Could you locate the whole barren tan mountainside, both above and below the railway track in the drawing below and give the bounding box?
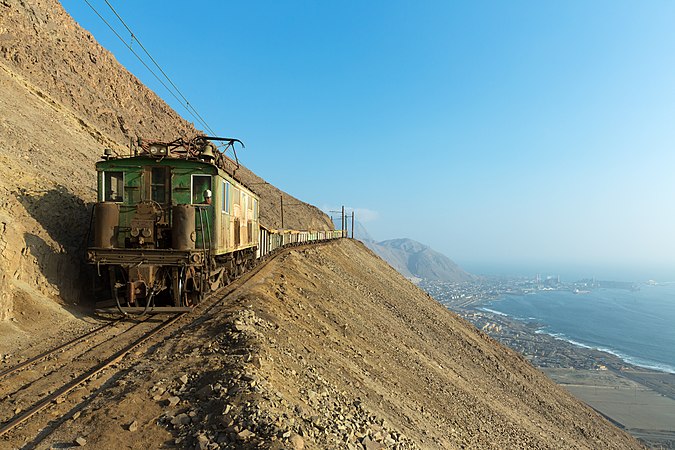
[0,0,640,450]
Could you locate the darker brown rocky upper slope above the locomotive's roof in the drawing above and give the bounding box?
[0,0,195,147]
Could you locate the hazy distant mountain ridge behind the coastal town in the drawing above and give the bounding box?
[364,238,477,282]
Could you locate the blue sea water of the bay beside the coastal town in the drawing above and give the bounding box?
[486,283,675,373]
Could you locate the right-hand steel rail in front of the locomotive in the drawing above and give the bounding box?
[0,314,183,436]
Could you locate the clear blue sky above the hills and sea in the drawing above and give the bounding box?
[63,0,675,279]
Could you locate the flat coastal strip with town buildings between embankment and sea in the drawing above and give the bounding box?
[427,285,675,449]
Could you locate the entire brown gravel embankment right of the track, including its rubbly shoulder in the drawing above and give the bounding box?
[31,240,642,450]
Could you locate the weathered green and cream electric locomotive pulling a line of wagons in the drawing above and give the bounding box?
[86,136,344,314]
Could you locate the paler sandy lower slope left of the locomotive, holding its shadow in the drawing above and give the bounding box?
[0,64,100,322]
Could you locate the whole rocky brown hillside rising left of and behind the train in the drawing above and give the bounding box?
[0,0,332,325]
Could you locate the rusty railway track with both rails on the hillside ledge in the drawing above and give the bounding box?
[0,237,338,446]
